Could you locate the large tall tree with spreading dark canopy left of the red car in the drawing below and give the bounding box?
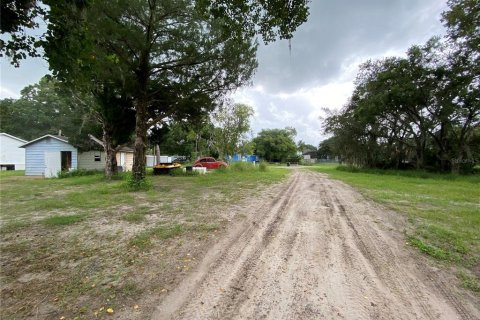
[44,0,308,181]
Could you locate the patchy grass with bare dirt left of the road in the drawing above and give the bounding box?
[0,166,288,319]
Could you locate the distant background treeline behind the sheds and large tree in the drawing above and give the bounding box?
[0,76,300,166]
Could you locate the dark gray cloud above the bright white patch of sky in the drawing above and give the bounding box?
[255,0,445,92]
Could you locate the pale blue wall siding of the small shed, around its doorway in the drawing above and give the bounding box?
[25,137,78,176]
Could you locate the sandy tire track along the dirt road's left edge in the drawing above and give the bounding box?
[153,174,299,319]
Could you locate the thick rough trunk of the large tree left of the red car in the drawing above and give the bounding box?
[132,99,148,183]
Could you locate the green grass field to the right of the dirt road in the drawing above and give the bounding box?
[313,164,480,293]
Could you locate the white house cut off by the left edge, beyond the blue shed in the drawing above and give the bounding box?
[0,132,27,170]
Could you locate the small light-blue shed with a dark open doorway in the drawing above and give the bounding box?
[21,134,77,178]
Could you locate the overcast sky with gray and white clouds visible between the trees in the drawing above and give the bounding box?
[0,0,447,145]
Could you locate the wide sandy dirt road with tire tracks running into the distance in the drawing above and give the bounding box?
[152,170,480,320]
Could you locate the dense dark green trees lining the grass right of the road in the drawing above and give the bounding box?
[323,0,480,172]
